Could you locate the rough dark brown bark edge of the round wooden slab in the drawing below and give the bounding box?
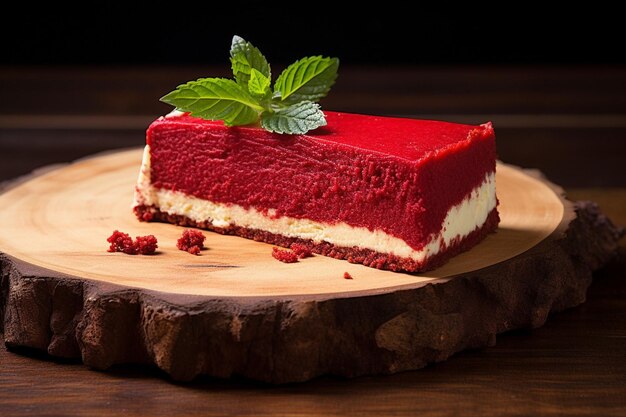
[0,202,624,383]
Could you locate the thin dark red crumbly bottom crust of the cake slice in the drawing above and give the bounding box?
[134,205,500,272]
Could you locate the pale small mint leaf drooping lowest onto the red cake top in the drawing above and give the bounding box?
[261,101,326,135]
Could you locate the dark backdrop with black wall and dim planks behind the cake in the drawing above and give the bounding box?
[0,5,626,187]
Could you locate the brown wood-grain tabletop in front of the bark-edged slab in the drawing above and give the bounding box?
[0,237,626,417]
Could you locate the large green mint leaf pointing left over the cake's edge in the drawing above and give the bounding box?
[161,78,264,126]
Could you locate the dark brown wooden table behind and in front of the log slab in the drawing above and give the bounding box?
[0,68,626,416]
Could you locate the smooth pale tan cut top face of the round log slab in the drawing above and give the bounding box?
[0,149,573,298]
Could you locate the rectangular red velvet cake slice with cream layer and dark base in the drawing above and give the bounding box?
[134,112,499,272]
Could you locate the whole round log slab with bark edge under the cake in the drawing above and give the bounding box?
[0,150,624,383]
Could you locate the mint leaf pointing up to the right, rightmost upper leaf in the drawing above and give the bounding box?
[274,56,339,104]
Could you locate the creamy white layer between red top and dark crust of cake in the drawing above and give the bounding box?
[134,146,497,262]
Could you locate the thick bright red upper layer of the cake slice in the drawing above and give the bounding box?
[147,112,496,249]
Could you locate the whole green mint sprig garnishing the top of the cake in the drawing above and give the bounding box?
[161,36,339,134]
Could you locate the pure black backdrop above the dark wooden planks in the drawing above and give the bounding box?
[0,6,626,65]
